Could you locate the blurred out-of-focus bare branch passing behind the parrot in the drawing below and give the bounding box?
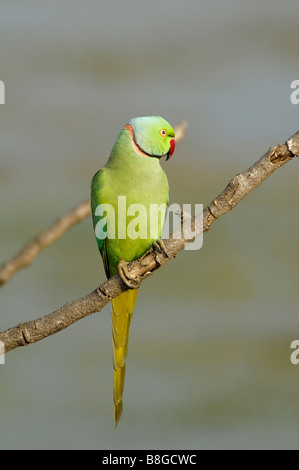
[0,121,188,287]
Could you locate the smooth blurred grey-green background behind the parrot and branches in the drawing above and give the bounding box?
[0,0,299,449]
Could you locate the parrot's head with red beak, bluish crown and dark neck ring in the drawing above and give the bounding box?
[125,116,175,160]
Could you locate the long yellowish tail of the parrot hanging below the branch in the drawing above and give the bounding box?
[111,290,138,427]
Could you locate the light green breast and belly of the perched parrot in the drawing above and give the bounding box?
[92,152,169,276]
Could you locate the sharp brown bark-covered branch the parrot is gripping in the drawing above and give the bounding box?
[0,126,299,352]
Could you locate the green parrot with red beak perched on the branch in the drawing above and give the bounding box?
[91,116,175,427]
